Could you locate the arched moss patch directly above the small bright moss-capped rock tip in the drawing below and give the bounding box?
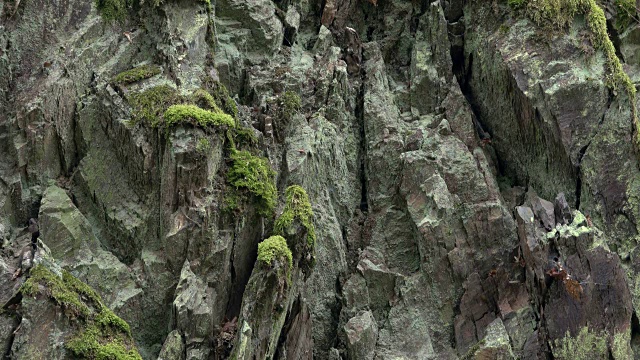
[273,185,316,249]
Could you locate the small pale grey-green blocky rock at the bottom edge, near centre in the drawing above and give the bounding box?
[344,311,378,360]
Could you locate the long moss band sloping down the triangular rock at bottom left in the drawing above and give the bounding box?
[20,264,142,360]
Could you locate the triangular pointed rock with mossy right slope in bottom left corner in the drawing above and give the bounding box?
[10,256,141,359]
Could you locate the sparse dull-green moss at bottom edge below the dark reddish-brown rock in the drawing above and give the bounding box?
[551,326,609,360]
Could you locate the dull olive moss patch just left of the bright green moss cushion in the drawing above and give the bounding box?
[128,85,183,126]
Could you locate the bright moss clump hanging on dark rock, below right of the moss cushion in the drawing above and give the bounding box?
[227,145,278,216]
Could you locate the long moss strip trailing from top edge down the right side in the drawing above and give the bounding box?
[523,0,640,163]
